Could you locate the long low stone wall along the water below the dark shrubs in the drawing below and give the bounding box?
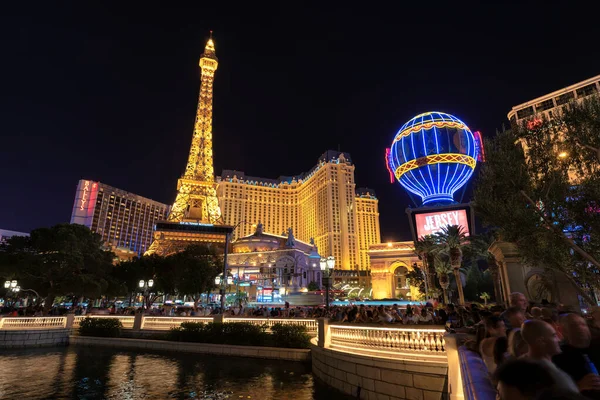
[69,336,310,361]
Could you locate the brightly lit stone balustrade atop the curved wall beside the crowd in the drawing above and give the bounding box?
[319,321,447,362]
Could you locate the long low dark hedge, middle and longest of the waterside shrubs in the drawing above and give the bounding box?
[168,322,268,346]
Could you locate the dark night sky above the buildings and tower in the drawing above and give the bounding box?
[0,1,600,240]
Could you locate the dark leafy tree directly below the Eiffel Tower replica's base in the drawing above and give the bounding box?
[168,245,223,308]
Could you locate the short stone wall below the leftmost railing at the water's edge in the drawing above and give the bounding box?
[0,329,70,349]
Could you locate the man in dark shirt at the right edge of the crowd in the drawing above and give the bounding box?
[553,314,600,399]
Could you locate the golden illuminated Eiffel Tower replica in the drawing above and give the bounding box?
[145,31,232,256]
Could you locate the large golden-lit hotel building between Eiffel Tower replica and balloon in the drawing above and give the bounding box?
[217,151,380,270]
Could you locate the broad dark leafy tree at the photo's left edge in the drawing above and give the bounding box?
[0,224,114,311]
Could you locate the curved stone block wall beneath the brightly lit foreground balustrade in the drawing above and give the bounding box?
[311,346,448,400]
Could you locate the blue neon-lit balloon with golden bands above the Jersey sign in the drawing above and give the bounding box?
[386,111,477,205]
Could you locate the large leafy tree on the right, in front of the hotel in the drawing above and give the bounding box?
[475,97,600,304]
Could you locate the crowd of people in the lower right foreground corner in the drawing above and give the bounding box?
[467,293,600,400]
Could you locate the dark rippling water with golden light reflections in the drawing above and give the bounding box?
[0,346,346,400]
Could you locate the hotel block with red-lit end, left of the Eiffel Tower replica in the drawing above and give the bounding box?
[71,179,169,255]
